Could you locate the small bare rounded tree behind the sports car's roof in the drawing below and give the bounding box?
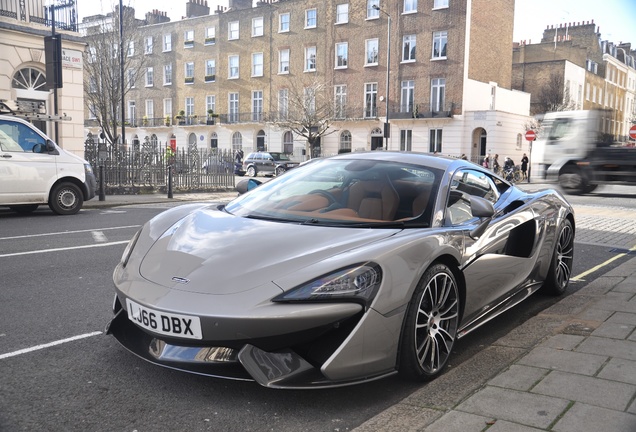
[270,80,337,156]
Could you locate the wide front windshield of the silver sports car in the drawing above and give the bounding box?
[225,157,443,227]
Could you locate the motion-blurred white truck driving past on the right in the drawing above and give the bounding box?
[531,110,636,194]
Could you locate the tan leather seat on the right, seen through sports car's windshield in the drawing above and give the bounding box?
[347,179,400,221]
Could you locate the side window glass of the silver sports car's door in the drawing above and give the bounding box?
[446,170,499,225]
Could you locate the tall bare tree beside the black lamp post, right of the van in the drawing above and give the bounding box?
[84,7,145,145]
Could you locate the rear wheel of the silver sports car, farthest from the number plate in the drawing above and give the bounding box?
[541,219,574,296]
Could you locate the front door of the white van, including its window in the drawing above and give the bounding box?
[0,120,57,204]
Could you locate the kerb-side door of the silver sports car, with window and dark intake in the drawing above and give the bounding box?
[446,169,537,324]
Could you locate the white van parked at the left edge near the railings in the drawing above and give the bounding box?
[0,115,96,215]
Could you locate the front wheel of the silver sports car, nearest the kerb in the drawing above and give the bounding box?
[398,263,460,381]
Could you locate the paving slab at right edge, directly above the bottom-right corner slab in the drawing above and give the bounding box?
[532,371,636,411]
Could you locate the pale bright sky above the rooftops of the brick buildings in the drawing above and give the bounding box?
[77,0,636,49]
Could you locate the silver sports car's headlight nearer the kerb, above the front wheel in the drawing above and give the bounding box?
[272,263,382,307]
